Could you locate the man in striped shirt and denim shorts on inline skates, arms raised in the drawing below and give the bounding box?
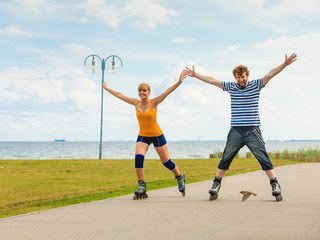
[186,53,297,201]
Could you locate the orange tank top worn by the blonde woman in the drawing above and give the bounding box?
[136,102,162,137]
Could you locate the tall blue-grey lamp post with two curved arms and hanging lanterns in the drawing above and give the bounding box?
[84,54,123,159]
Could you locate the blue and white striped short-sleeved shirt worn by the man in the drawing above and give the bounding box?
[222,78,263,127]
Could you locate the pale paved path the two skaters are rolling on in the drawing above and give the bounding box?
[0,163,320,240]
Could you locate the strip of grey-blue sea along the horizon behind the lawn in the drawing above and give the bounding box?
[0,140,320,160]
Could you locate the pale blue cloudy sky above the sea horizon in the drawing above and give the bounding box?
[0,0,320,141]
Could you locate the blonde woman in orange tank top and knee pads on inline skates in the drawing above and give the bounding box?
[102,70,187,199]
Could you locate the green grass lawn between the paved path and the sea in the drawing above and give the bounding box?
[0,159,301,218]
